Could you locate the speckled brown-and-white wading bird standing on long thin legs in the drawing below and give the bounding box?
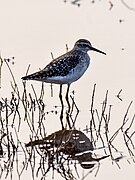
[22,39,106,119]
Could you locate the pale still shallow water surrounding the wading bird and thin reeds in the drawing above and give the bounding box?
[0,0,135,180]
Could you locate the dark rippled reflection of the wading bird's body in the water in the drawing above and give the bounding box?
[26,130,108,169]
